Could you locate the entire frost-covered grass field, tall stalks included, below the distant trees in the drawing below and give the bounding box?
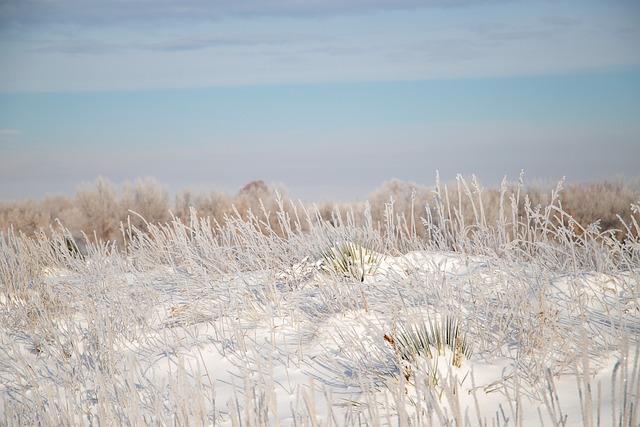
[0,177,640,426]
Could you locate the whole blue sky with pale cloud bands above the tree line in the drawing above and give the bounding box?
[0,0,640,201]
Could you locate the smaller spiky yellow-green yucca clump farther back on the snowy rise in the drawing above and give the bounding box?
[322,241,384,282]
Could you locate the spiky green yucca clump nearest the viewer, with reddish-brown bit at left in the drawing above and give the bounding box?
[384,316,473,380]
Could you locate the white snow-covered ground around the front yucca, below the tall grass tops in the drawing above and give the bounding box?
[0,226,640,426]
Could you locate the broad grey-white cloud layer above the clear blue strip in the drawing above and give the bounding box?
[0,0,640,91]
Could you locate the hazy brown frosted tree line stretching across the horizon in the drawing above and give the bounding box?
[0,177,640,247]
